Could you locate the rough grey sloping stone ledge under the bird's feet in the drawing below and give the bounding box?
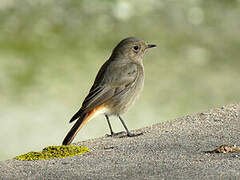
[0,104,240,179]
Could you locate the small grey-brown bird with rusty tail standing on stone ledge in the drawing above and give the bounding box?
[62,37,156,145]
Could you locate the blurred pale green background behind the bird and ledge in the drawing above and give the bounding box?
[0,0,240,160]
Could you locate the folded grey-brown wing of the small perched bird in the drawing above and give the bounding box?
[81,62,138,112]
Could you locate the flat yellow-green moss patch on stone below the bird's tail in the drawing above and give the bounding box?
[14,145,89,161]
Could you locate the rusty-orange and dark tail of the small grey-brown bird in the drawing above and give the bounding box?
[62,106,104,145]
